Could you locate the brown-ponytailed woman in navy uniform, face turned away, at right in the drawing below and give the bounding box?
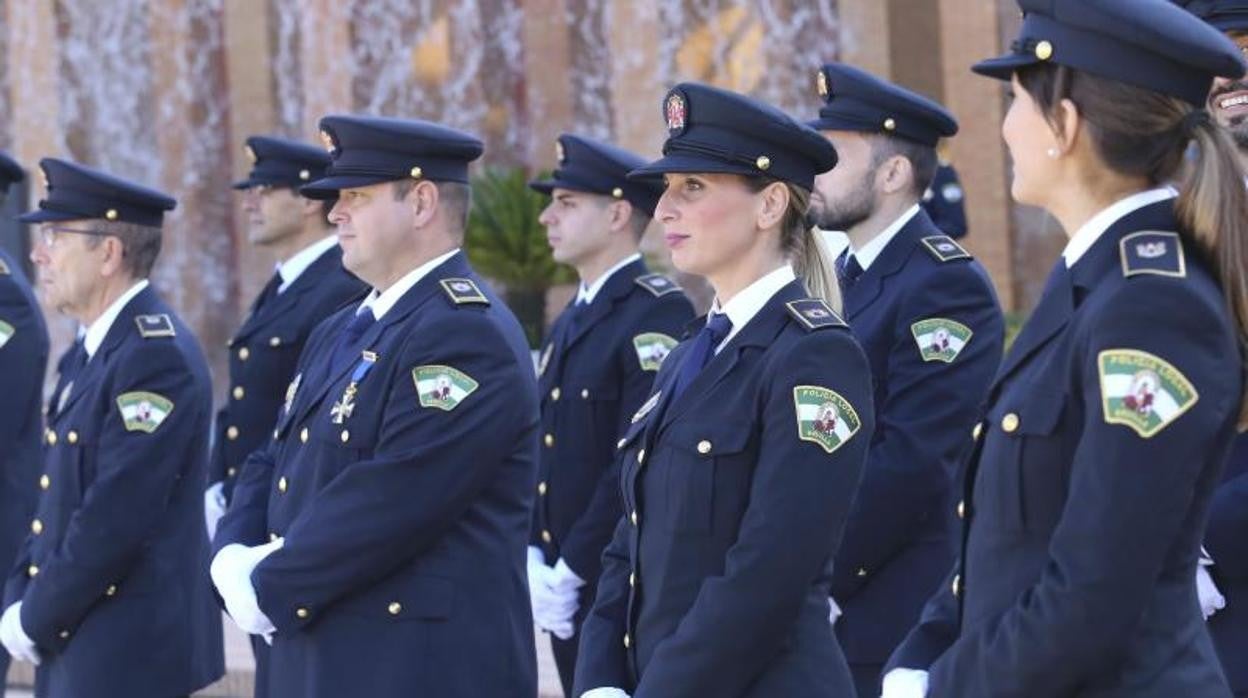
[884,0,1248,698]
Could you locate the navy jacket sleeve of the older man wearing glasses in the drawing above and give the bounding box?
[21,340,211,648]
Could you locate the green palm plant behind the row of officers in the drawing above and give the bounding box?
[464,167,575,347]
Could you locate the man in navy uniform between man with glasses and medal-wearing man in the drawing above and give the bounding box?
[205,136,364,536]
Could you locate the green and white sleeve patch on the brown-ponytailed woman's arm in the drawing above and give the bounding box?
[1097,350,1201,438]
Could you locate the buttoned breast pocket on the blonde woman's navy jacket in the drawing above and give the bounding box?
[655,422,756,533]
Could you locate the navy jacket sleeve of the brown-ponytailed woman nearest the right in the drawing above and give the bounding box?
[929,277,1241,698]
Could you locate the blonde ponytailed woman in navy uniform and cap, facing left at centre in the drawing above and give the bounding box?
[575,84,874,698]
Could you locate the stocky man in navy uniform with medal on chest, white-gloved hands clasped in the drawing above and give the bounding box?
[211,116,538,698]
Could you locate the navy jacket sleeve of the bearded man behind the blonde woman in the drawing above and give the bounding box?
[832,262,1005,603]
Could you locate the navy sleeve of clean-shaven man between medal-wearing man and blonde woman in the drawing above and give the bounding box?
[559,293,693,579]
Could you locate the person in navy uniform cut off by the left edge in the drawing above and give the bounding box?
[0,152,47,677]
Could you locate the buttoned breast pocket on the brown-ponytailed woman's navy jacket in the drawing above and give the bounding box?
[976,387,1070,532]
